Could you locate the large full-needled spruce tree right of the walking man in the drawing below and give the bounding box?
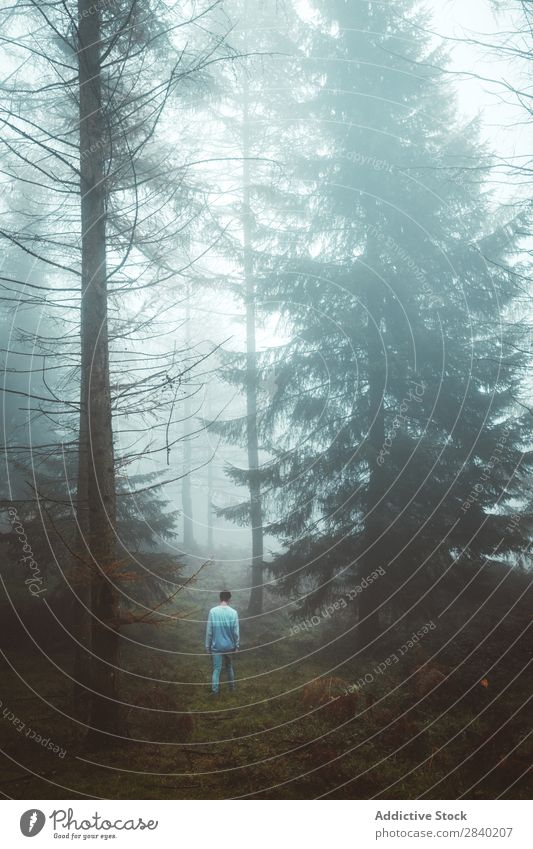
[256,0,527,651]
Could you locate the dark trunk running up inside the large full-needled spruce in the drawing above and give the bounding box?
[357,208,386,652]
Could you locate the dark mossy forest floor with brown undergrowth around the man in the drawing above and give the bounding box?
[0,572,533,799]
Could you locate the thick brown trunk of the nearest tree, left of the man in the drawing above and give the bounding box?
[78,0,122,742]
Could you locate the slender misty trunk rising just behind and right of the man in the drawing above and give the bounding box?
[242,72,264,616]
